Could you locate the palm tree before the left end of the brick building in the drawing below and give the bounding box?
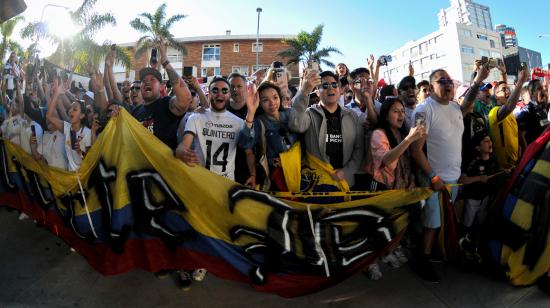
[130,3,187,58]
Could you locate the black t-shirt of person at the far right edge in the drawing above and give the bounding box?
[517,102,548,144]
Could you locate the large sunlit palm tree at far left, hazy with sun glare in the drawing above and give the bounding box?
[21,0,131,73]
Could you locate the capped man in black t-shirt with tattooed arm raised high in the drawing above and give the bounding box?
[132,42,191,150]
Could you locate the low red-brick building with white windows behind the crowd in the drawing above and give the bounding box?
[113,31,298,82]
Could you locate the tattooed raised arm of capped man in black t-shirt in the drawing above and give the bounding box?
[159,40,192,116]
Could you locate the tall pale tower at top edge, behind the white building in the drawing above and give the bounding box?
[437,0,493,31]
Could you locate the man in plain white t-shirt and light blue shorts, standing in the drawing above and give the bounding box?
[411,69,473,283]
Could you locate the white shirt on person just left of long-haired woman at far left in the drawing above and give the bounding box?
[38,130,68,170]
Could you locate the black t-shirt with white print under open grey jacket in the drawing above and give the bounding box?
[323,106,344,169]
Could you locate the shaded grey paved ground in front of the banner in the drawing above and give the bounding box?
[0,208,550,308]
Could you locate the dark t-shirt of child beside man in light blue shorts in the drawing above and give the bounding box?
[464,156,498,200]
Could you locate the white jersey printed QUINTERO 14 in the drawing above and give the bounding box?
[185,109,244,180]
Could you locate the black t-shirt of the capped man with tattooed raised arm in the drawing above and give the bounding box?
[132,96,182,150]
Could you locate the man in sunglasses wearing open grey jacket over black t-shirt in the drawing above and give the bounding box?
[289,71,363,187]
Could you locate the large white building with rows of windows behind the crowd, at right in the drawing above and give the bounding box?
[381,23,502,84]
